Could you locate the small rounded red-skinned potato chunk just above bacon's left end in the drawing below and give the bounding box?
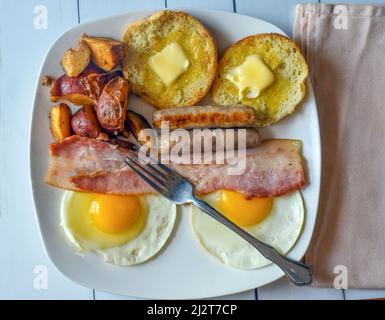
[71,105,101,138]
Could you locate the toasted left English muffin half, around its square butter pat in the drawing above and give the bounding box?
[122,10,218,109]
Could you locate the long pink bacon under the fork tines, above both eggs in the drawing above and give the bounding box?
[46,136,306,198]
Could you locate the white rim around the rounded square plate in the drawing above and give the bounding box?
[28,7,322,299]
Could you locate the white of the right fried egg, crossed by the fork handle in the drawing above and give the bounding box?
[191,191,305,269]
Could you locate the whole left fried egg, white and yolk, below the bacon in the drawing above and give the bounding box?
[61,191,176,266]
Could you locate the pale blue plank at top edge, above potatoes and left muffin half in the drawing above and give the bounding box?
[79,0,165,22]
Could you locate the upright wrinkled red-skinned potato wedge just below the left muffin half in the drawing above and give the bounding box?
[95,77,129,135]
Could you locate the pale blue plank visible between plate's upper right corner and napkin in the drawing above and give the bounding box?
[236,0,318,36]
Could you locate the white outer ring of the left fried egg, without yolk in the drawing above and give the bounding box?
[61,191,176,266]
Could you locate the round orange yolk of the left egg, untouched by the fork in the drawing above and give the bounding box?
[89,195,141,234]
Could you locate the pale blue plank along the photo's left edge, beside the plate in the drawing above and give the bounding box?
[0,0,92,299]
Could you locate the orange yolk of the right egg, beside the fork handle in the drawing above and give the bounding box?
[216,190,273,227]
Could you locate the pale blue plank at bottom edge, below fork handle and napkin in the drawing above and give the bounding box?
[258,278,344,300]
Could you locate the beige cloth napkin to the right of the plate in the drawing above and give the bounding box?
[294,4,385,288]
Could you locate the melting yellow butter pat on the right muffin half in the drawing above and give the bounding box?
[226,54,274,99]
